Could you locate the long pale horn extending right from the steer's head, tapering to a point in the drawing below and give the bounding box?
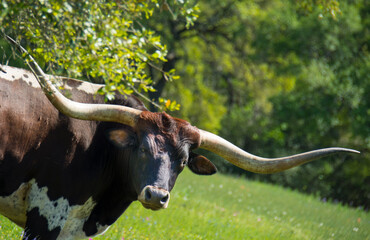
[199,129,360,173]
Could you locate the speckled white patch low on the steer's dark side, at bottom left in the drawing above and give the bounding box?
[0,179,109,240]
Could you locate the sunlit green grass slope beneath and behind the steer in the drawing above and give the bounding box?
[0,170,370,240]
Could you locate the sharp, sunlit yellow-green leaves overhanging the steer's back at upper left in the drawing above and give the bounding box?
[0,0,197,107]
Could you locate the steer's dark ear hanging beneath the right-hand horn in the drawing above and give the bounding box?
[188,153,217,175]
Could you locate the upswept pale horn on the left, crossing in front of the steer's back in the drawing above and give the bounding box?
[6,36,142,127]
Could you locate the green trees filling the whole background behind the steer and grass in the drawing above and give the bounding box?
[0,0,370,208]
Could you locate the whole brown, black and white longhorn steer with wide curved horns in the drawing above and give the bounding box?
[0,37,357,239]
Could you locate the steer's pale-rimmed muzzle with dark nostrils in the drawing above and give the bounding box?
[138,186,170,210]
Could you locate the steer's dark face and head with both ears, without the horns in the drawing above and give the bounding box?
[108,111,217,210]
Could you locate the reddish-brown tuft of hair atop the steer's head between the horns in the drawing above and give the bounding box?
[137,111,200,148]
